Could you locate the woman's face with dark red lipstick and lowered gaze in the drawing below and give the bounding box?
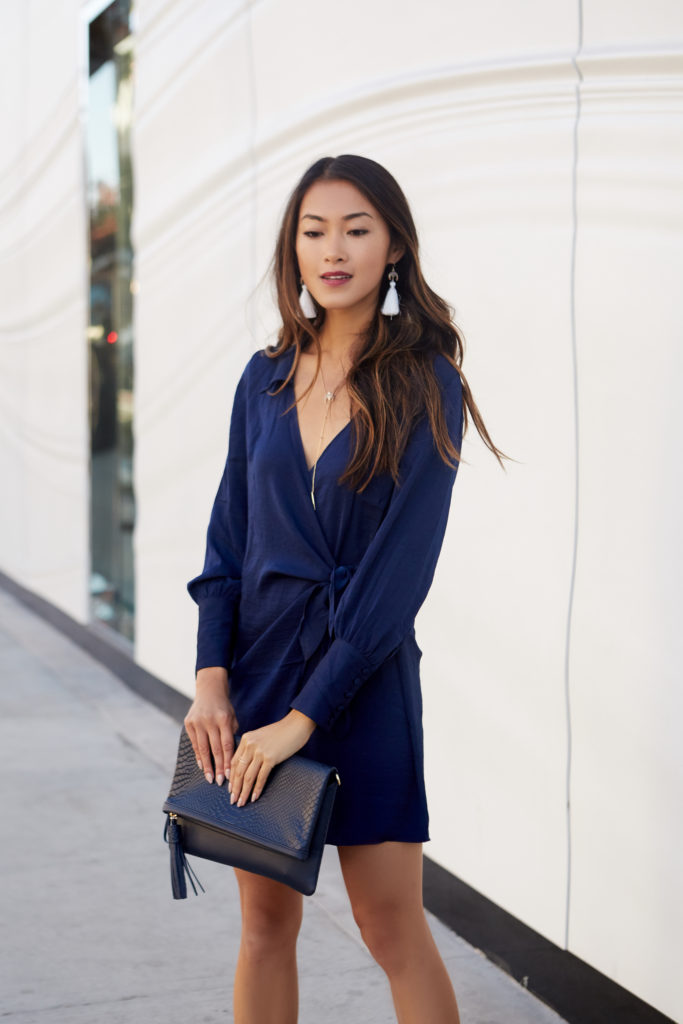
[296,181,404,319]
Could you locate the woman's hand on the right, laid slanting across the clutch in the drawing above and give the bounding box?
[228,709,315,807]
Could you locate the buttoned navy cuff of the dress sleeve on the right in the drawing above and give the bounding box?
[290,638,373,731]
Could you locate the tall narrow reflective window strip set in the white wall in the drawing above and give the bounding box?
[86,0,135,641]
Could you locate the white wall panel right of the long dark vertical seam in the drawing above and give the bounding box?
[569,8,683,1003]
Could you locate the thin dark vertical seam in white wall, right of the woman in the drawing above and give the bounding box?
[564,0,584,949]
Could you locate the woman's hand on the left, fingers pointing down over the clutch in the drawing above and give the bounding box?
[184,668,239,785]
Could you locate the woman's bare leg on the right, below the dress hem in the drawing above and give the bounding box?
[339,843,460,1024]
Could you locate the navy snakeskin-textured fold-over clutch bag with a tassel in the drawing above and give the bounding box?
[164,726,339,899]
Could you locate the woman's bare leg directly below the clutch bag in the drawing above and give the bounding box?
[233,868,303,1024]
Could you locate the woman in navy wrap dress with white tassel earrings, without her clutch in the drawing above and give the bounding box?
[185,156,500,1024]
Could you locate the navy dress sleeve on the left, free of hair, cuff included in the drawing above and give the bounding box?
[187,374,247,672]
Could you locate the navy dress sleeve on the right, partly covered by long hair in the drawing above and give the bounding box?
[291,367,463,730]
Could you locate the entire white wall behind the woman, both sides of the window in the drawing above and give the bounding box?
[0,0,683,1018]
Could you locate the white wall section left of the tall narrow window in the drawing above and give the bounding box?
[0,0,89,621]
